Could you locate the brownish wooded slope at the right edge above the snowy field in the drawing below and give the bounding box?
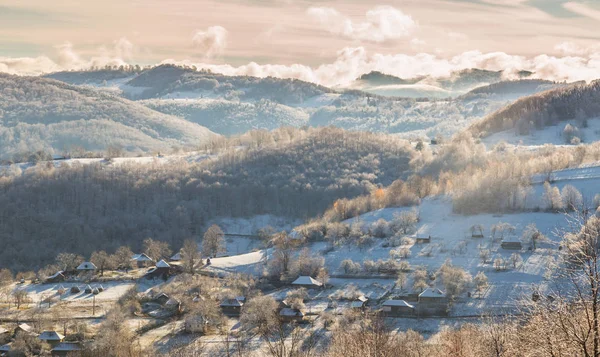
[471,81,600,136]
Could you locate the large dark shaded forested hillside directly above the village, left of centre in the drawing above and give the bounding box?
[0,128,416,269]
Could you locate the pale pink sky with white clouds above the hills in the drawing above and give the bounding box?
[0,0,600,86]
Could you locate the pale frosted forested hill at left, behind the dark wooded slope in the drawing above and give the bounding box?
[0,74,215,159]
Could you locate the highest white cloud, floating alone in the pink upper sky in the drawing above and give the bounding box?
[307,6,417,42]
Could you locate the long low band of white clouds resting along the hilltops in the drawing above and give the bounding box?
[0,39,600,87]
